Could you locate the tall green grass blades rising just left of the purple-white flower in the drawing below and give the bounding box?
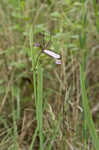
[30,28,43,150]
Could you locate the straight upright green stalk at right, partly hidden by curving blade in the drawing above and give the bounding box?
[80,0,88,150]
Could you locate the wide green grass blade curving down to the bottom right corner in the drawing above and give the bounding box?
[80,66,99,150]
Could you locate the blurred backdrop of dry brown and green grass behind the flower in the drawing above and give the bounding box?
[0,0,99,150]
